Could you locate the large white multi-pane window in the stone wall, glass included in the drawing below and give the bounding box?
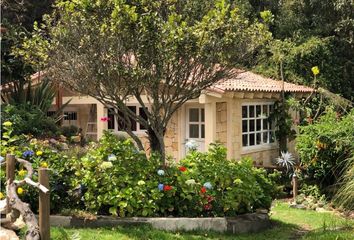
[242,103,274,147]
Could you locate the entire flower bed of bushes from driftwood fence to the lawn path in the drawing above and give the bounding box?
[1,126,280,217]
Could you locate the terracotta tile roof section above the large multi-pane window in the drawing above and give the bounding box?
[212,71,313,93]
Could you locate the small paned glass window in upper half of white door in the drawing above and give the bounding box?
[188,108,205,139]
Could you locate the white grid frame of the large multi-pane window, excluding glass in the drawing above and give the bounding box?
[240,102,277,151]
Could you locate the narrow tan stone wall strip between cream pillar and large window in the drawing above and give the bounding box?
[216,102,227,147]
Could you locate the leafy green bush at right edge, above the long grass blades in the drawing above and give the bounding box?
[296,108,354,190]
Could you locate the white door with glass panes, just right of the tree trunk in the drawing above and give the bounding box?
[185,104,205,152]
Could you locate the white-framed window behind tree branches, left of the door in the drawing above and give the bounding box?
[108,106,147,131]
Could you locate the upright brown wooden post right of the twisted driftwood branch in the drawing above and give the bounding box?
[38,168,50,240]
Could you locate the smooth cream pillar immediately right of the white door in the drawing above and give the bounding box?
[204,102,216,151]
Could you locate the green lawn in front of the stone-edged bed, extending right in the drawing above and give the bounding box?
[51,201,354,240]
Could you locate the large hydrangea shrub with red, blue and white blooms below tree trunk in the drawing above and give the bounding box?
[77,133,276,217]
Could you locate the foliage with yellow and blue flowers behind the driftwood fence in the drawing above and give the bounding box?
[0,122,80,213]
